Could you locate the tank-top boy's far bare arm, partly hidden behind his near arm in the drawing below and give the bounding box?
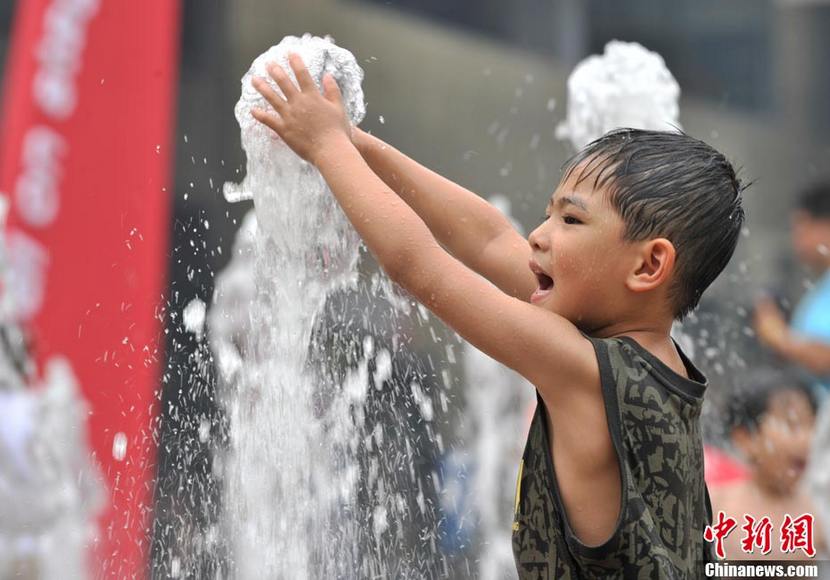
[352,128,537,300]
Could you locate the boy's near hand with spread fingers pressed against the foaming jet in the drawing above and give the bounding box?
[251,54,358,165]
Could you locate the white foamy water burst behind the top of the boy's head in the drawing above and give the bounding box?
[556,40,680,150]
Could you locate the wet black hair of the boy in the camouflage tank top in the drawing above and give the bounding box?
[563,129,748,319]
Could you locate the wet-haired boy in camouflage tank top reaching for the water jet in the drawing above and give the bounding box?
[252,55,743,578]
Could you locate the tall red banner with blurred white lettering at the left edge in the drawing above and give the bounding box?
[0,0,179,578]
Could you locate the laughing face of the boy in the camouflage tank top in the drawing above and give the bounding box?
[528,167,635,332]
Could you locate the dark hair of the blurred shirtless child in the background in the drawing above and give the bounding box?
[727,368,817,432]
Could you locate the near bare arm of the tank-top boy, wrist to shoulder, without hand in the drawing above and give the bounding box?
[314,137,598,398]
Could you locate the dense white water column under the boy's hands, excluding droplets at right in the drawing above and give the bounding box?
[218,35,365,579]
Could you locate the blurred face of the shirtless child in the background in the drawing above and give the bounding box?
[735,389,815,493]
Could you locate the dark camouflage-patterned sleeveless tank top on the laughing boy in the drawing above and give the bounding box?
[513,337,713,580]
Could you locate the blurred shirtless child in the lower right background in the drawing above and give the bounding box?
[712,370,819,560]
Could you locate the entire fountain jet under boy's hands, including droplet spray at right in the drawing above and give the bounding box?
[218,35,446,579]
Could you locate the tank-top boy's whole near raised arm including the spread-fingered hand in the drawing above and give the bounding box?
[253,56,599,408]
